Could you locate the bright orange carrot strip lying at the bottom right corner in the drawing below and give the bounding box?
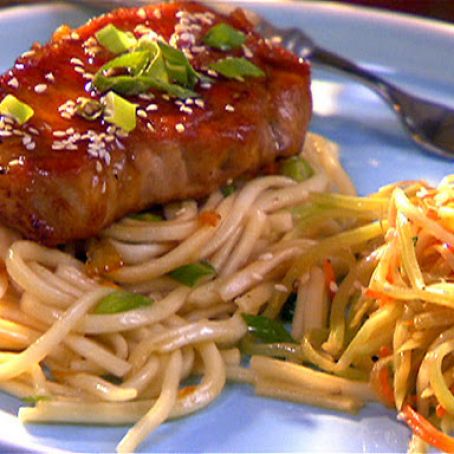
[401,404,454,453]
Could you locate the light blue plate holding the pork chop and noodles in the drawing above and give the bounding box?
[0,1,454,452]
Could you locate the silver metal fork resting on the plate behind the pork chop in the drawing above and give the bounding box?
[3,0,454,159]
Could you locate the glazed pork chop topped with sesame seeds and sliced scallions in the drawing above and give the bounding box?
[0,2,311,245]
